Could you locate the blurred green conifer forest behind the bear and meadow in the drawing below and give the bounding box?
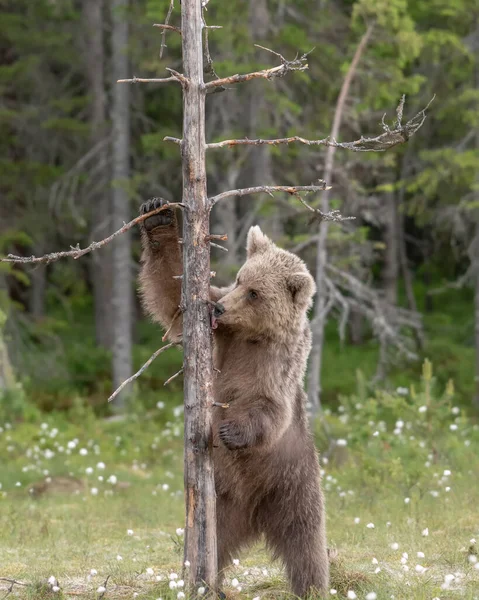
[0,0,479,418]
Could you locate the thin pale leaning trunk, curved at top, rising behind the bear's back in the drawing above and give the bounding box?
[308,25,373,418]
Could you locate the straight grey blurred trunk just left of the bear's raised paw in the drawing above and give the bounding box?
[111,0,133,407]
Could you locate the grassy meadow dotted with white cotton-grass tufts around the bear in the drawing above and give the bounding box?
[0,369,479,600]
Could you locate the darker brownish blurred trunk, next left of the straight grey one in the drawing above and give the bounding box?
[83,0,112,348]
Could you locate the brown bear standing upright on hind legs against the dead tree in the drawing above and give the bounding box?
[140,198,329,596]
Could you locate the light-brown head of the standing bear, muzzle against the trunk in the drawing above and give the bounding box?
[217,226,316,339]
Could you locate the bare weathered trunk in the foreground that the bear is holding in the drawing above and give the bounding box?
[181,0,217,588]
